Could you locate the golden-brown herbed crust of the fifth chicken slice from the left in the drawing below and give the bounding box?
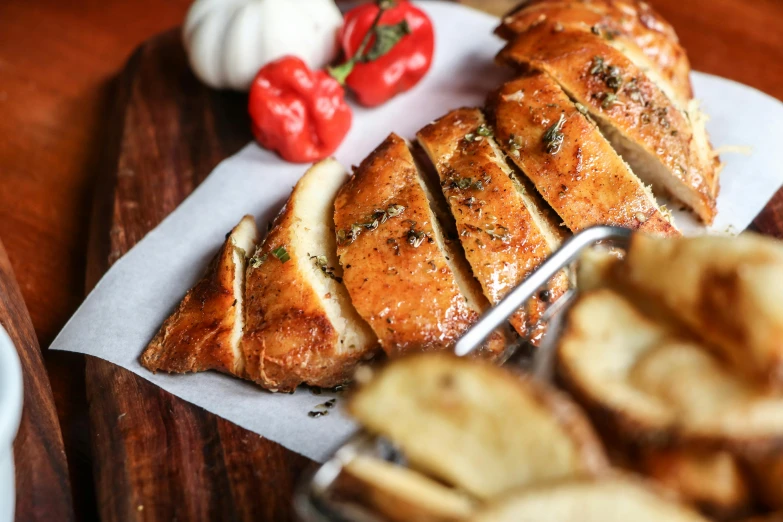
[490,74,679,235]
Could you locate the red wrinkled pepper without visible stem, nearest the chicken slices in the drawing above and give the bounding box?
[248,56,351,163]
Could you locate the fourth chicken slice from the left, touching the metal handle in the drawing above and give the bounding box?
[418,109,568,339]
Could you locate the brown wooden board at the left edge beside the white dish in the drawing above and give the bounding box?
[0,239,74,522]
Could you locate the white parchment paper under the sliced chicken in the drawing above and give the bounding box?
[51,2,783,461]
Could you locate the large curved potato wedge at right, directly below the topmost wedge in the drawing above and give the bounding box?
[556,289,783,451]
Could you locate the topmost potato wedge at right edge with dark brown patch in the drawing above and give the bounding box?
[619,234,783,389]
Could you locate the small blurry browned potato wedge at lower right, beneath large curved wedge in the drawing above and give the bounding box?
[639,449,754,520]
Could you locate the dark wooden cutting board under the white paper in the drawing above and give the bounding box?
[86,14,783,522]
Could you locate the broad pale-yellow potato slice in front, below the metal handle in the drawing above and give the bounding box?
[349,354,606,499]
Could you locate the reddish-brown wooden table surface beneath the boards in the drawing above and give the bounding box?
[0,0,783,520]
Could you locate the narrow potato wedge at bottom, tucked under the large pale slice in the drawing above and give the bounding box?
[340,456,476,522]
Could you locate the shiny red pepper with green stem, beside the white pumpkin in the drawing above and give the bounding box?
[329,0,435,107]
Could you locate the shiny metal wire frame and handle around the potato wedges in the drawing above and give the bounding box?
[294,226,633,522]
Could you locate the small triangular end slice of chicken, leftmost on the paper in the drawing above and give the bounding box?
[141,216,257,375]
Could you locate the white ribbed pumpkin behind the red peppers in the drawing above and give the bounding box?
[182,0,343,91]
